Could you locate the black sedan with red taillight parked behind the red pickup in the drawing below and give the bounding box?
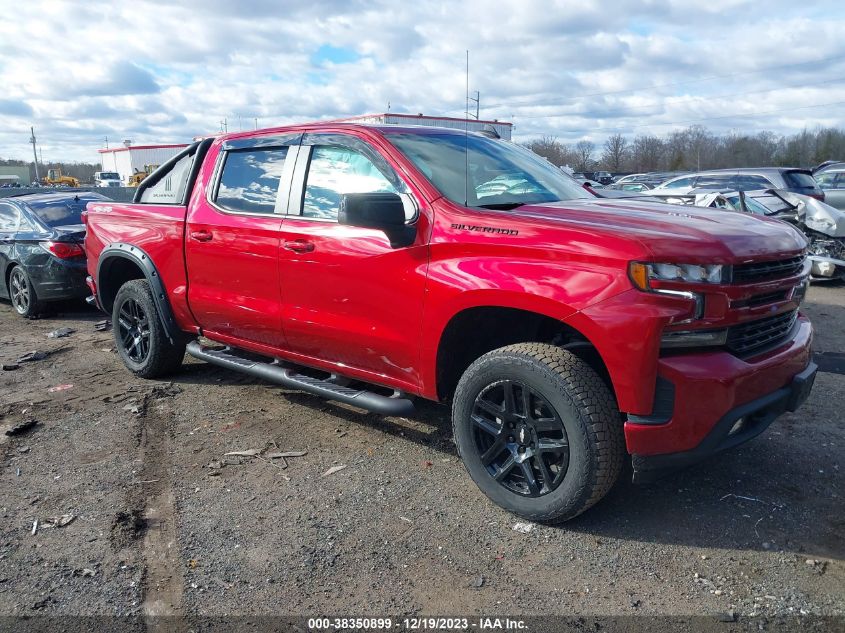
[0,192,108,317]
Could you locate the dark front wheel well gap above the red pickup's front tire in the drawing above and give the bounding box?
[437,306,614,400]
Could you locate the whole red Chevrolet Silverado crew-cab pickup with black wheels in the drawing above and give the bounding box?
[86,123,816,521]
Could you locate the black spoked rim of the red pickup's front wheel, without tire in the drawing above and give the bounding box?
[472,380,569,497]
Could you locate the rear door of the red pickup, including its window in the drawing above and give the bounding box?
[185,134,301,348]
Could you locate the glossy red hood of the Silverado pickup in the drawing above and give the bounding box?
[513,198,807,264]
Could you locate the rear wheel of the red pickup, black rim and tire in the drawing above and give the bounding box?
[112,279,185,378]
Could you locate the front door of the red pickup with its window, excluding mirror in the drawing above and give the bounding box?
[279,134,428,391]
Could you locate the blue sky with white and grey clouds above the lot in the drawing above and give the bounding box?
[0,0,845,162]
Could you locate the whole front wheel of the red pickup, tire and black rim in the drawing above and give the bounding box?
[452,343,624,523]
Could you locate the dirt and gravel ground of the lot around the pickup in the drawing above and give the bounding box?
[0,286,845,622]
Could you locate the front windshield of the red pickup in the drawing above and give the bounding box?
[387,132,594,209]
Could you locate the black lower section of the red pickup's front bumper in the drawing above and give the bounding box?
[632,362,818,483]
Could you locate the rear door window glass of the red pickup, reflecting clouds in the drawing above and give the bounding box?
[214,147,288,215]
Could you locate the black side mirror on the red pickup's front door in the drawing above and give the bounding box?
[337,193,417,248]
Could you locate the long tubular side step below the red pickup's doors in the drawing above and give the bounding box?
[186,341,414,415]
